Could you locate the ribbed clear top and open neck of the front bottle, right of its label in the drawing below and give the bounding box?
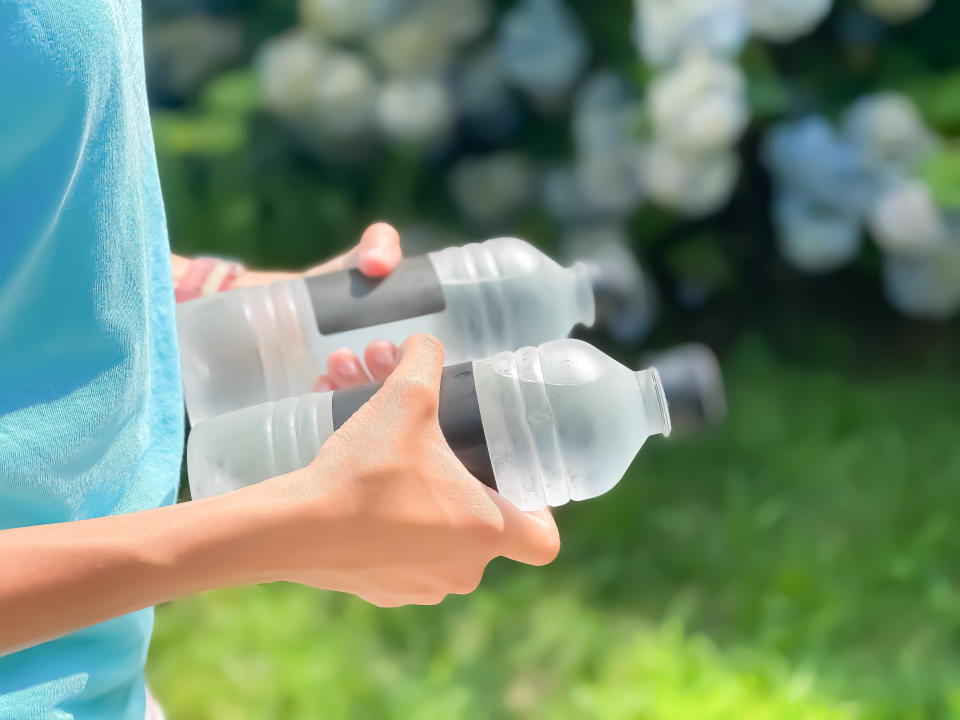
[474,340,670,510]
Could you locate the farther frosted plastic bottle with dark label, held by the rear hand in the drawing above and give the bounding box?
[177,238,594,424]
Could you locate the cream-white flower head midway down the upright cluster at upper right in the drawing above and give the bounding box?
[650,52,749,152]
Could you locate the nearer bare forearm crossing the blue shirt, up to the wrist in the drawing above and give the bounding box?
[0,488,282,655]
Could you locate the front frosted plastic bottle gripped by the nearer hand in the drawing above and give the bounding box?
[187,339,670,510]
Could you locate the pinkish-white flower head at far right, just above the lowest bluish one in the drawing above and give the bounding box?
[867,180,947,255]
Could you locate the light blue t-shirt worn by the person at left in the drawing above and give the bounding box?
[0,0,183,720]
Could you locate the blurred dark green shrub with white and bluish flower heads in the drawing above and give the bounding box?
[146,0,960,330]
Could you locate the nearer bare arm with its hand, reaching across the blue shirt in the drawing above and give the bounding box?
[0,336,559,654]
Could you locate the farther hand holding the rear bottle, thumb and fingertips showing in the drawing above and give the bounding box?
[234,222,401,392]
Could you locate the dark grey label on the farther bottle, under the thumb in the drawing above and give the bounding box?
[306,255,446,335]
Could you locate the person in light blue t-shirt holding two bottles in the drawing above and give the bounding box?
[0,0,559,720]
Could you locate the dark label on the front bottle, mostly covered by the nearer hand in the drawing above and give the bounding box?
[331,362,497,490]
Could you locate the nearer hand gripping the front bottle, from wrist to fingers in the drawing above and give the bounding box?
[255,335,560,607]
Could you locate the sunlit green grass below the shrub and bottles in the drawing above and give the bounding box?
[148,341,960,720]
